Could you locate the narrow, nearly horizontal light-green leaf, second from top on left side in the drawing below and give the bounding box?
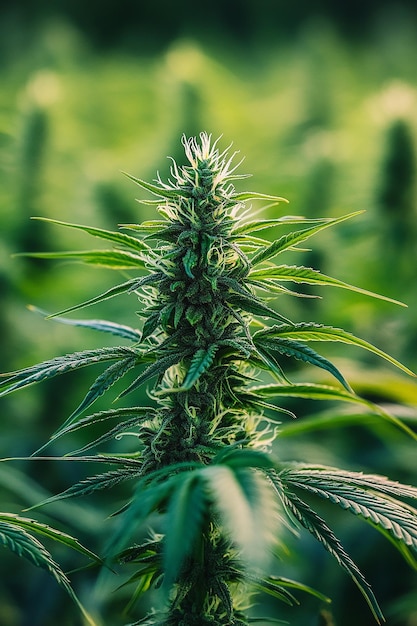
[19,250,145,270]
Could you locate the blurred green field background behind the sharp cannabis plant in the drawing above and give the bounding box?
[0,0,417,626]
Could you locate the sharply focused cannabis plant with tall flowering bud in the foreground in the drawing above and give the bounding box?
[0,133,417,626]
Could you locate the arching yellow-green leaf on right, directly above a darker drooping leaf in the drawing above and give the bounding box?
[254,322,416,377]
